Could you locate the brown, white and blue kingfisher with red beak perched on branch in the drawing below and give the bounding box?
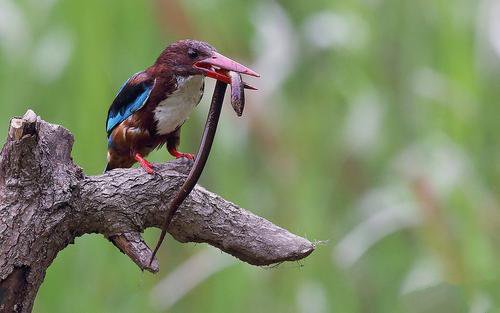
[105,40,259,174]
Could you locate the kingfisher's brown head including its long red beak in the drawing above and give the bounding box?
[155,39,260,83]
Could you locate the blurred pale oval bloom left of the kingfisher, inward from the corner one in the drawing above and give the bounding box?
[33,30,73,83]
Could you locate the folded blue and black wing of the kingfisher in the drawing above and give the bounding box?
[106,73,154,136]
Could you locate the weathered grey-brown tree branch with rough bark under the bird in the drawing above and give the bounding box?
[0,111,314,312]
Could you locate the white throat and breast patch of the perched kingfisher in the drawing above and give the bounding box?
[154,75,204,135]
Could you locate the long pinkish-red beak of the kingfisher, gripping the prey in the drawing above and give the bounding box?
[194,51,260,90]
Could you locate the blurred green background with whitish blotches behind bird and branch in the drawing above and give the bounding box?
[0,0,500,313]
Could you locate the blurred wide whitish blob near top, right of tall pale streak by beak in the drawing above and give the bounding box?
[303,11,368,49]
